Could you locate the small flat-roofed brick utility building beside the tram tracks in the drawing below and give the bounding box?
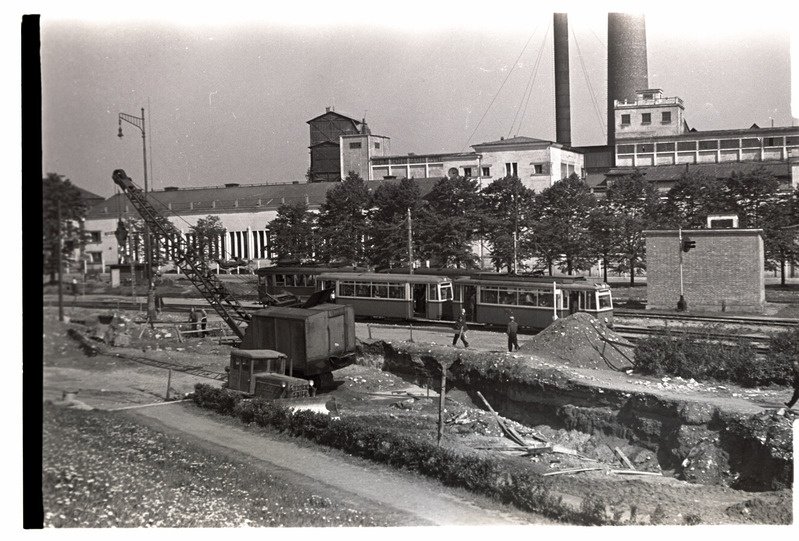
[644,229,766,313]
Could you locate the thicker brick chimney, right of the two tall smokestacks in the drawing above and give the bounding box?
[608,13,649,145]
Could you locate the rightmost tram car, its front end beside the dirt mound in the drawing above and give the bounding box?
[453,273,613,330]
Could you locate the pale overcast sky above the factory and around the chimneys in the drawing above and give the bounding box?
[41,0,799,196]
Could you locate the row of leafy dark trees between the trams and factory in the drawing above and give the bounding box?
[268,167,799,284]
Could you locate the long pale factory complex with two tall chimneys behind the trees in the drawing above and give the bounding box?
[76,13,799,271]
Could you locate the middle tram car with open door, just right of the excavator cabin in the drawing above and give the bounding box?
[317,272,455,321]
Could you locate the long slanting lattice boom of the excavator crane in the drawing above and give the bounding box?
[112,169,250,340]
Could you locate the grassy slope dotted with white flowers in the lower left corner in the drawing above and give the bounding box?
[42,403,402,528]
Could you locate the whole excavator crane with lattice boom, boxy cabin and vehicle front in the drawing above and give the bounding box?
[112,169,355,399]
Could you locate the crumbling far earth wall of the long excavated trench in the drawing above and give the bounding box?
[360,332,794,492]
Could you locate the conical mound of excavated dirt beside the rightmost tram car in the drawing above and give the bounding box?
[519,312,633,370]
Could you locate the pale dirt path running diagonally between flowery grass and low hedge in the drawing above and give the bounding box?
[125,402,551,526]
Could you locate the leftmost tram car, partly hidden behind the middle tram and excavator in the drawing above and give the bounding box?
[256,265,366,304]
